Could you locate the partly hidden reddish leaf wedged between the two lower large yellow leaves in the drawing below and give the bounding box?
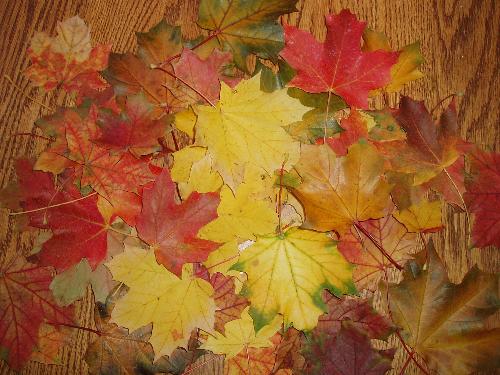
[210,273,248,333]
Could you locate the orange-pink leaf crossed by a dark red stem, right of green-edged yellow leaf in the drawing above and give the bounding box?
[338,215,417,289]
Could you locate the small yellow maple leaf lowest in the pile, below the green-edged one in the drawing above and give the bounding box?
[201,307,282,359]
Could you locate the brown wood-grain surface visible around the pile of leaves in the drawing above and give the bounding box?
[0,0,500,375]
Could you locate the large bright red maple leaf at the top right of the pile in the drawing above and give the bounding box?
[281,10,398,108]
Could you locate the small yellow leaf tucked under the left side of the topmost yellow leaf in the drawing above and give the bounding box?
[170,146,222,200]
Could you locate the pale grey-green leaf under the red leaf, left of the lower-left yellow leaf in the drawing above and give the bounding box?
[50,259,92,306]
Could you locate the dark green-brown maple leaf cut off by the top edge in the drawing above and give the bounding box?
[198,0,296,71]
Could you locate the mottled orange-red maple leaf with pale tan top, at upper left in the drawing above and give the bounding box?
[25,16,111,92]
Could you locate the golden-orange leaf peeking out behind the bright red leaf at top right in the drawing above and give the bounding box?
[363,28,424,92]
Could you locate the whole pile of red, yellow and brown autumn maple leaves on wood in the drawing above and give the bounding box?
[0,0,500,375]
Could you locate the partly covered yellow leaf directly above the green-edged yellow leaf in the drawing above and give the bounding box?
[199,175,278,243]
